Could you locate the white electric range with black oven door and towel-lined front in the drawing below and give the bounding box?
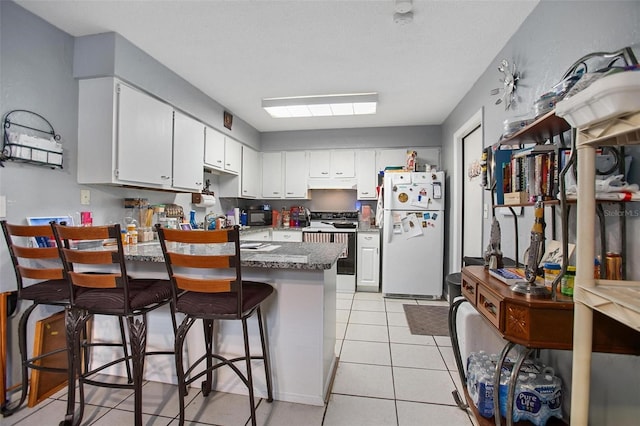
[302,211,358,293]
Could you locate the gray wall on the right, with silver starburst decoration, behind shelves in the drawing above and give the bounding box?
[442,1,640,425]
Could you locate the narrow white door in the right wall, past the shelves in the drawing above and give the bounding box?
[462,126,483,257]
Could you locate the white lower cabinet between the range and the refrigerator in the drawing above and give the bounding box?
[356,229,380,292]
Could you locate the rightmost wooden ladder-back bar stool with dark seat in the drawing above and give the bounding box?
[157,226,273,425]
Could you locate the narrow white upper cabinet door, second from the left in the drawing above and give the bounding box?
[173,111,204,191]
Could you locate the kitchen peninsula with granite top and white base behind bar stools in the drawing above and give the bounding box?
[89,242,344,405]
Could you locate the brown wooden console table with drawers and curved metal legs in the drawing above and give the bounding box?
[449,266,640,425]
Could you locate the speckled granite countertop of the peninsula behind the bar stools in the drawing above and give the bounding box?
[125,241,346,269]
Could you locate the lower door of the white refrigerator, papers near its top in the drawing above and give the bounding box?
[382,210,444,299]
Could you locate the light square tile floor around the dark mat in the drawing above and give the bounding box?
[0,293,474,426]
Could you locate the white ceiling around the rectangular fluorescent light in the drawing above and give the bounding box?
[16,0,538,132]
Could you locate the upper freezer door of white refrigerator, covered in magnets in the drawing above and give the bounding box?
[384,172,444,211]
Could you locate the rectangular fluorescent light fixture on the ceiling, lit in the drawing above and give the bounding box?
[262,92,378,118]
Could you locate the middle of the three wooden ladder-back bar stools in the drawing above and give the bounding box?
[51,223,176,426]
